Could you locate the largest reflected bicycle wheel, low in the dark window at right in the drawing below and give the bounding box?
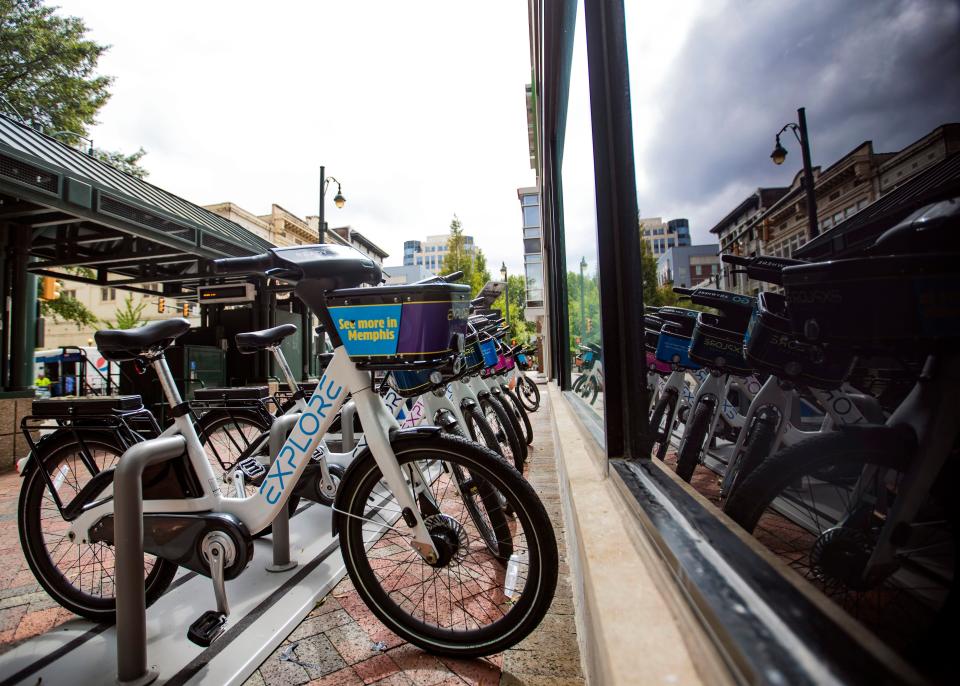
[724,426,960,667]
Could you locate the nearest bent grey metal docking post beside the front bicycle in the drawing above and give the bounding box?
[113,436,187,686]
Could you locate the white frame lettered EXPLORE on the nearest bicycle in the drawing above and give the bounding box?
[70,346,437,561]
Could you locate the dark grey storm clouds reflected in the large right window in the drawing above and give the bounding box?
[638,0,960,239]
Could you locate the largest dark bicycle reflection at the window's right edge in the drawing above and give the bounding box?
[725,241,960,664]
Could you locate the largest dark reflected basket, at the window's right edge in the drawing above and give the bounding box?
[783,254,960,347]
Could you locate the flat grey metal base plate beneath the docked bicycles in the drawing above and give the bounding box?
[0,415,408,686]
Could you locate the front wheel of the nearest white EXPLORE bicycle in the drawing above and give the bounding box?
[338,435,558,658]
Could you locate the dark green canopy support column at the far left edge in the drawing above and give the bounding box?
[10,228,37,391]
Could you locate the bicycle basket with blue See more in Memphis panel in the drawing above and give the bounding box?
[327,283,470,369]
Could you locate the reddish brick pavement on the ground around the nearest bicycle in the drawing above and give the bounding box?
[0,392,584,686]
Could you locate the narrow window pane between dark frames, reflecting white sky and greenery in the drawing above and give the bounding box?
[561,2,603,428]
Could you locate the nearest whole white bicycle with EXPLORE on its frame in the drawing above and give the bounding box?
[21,245,558,657]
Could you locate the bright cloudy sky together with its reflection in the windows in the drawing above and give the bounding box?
[52,0,960,271]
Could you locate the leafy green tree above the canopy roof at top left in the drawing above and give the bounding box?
[0,0,146,178]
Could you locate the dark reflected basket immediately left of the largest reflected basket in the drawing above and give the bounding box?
[744,292,854,389]
